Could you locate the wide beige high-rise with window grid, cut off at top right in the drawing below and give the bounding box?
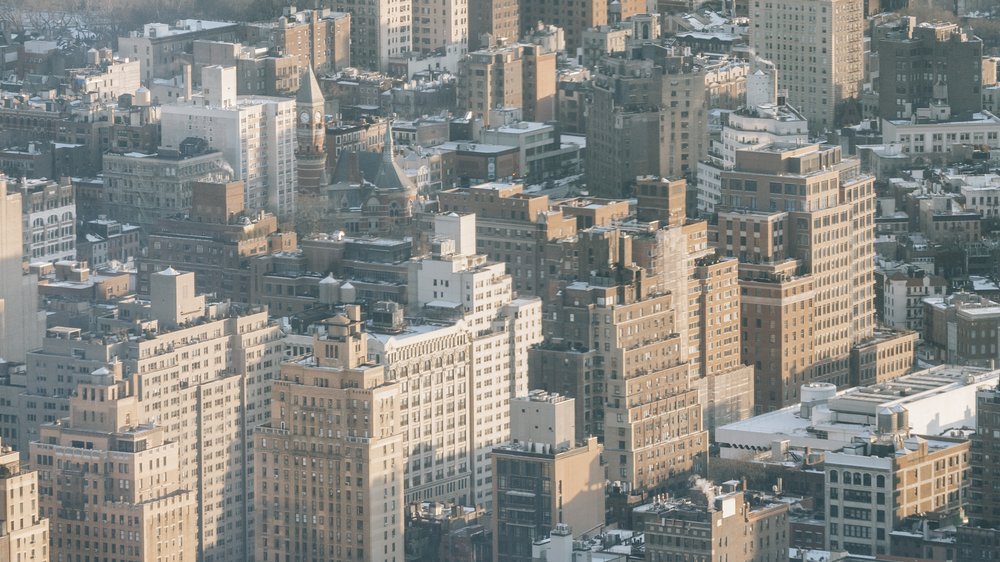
[750,0,865,132]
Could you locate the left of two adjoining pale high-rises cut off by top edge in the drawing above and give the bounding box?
[330,0,408,71]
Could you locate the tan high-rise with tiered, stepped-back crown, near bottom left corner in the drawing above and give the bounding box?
[31,362,198,562]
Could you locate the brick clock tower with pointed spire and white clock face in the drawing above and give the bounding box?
[295,66,326,194]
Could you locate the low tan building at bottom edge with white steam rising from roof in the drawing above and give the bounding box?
[637,481,789,562]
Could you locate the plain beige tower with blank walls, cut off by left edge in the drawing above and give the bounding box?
[0,182,45,361]
